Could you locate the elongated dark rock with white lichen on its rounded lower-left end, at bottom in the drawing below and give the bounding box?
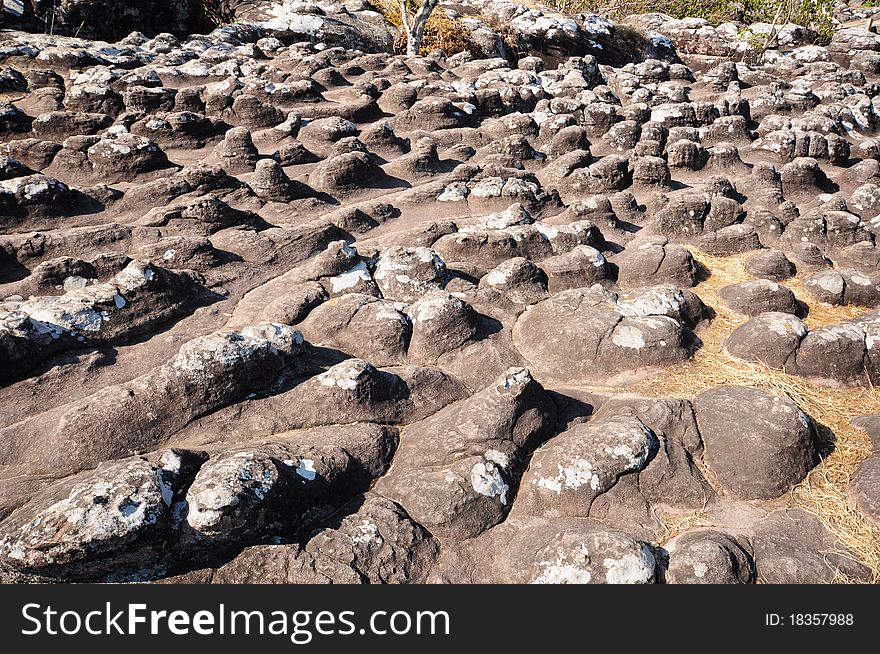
[180,424,398,548]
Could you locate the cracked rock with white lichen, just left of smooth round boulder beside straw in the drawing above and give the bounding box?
[513,398,715,539]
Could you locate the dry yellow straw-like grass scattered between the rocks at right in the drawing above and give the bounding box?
[634,249,880,583]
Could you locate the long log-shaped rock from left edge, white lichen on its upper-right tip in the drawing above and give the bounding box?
[0,326,302,477]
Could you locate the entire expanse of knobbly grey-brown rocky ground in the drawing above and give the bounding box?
[0,0,880,583]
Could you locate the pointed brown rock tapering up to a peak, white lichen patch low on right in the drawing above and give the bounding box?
[376,368,556,540]
